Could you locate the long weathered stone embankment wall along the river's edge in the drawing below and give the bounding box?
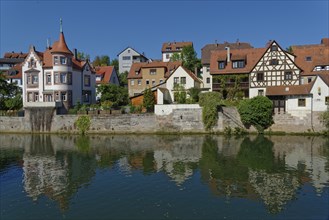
[0,107,325,135]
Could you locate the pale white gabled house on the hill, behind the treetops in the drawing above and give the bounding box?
[118,47,148,74]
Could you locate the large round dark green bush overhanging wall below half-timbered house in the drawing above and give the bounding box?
[238,96,273,133]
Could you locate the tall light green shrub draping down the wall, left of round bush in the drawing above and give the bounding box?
[199,92,221,130]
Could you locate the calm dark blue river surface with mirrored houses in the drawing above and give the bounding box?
[0,134,329,220]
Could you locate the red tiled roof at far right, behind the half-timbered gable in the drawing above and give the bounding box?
[291,38,329,75]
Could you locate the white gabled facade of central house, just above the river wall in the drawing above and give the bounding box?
[166,66,201,101]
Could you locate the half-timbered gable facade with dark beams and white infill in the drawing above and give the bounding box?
[249,41,301,98]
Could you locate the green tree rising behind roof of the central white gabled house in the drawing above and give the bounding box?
[170,45,202,72]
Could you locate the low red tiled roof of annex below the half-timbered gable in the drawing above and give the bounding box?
[266,81,314,96]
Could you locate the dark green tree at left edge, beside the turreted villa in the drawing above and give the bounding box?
[0,71,23,110]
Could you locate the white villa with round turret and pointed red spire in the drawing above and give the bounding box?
[22,22,96,113]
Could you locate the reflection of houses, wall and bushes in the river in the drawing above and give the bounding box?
[0,135,329,217]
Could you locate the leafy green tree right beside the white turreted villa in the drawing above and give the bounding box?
[97,84,129,108]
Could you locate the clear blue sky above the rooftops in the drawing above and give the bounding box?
[0,0,329,62]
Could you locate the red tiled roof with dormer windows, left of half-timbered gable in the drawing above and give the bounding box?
[210,48,267,75]
